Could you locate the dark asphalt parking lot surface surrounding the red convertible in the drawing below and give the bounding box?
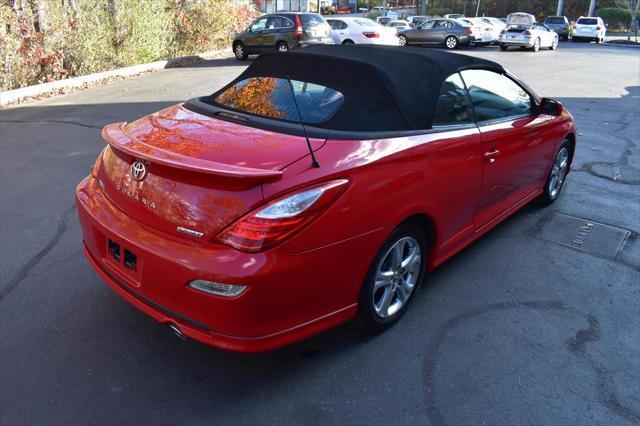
[0,43,640,425]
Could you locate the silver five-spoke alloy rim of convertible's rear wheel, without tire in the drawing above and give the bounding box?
[373,237,422,318]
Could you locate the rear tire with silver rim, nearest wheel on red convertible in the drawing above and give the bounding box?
[358,222,427,331]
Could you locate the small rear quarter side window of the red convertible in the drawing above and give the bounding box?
[433,73,473,126]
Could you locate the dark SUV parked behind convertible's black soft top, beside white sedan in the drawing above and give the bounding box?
[232,13,333,61]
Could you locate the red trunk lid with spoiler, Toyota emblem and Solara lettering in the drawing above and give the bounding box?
[97,105,324,239]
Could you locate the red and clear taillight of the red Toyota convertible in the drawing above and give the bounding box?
[216,179,349,252]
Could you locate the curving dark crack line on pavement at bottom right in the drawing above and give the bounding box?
[423,300,640,426]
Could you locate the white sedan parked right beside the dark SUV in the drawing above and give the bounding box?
[326,17,398,46]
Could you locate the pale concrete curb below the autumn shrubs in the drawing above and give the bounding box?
[0,49,232,108]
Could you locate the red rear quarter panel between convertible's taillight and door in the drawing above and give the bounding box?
[264,127,482,258]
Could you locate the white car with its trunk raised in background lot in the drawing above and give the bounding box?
[498,13,558,52]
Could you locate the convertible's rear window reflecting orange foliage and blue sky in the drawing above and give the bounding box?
[214,77,344,124]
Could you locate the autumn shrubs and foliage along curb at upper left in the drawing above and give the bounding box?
[0,0,258,90]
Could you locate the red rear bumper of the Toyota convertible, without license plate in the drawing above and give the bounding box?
[76,177,388,352]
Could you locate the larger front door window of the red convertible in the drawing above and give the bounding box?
[462,70,533,121]
